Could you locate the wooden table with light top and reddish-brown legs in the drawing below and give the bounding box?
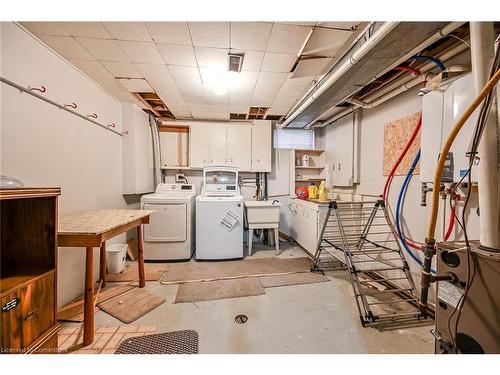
[57,209,153,345]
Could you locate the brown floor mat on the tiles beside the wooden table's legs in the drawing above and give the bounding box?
[97,288,165,323]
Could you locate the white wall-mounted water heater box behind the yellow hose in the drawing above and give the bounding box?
[420,73,480,182]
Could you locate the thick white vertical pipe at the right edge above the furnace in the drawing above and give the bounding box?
[470,22,500,249]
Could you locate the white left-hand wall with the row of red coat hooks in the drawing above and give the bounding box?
[0,23,142,306]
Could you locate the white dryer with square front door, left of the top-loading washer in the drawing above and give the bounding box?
[141,184,196,261]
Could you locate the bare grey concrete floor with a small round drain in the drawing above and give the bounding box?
[88,244,434,353]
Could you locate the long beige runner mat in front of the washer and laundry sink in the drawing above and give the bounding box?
[160,257,312,284]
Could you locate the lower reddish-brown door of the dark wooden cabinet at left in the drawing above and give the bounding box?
[1,271,55,349]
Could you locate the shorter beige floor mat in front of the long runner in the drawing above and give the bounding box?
[174,277,265,303]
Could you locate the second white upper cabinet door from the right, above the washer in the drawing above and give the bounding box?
[226,125,252,171]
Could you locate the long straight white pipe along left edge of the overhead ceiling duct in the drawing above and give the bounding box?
[279,22,398,128]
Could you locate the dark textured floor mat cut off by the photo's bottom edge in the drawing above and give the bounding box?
[115,330,199,354]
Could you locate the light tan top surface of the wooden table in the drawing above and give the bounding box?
[58,209,154,236]
